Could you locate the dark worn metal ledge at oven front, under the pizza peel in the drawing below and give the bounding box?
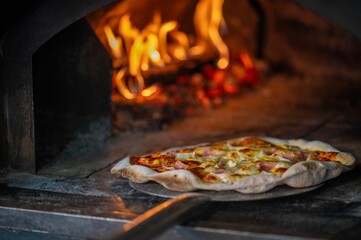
[0,166,361,240]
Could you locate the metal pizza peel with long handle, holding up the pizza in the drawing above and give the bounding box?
[108,182,323,240]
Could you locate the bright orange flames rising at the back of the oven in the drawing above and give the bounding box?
[104,0,229,100]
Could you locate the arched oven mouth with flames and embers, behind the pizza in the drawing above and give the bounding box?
[2,0,361,176]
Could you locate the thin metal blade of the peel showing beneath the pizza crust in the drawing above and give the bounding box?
[130,182,322,202]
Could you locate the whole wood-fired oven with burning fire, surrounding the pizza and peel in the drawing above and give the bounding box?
[0,0,361,239]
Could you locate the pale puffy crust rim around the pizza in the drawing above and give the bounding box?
[111,137,355,193]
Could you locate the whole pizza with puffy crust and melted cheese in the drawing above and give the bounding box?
[111,136,356,193]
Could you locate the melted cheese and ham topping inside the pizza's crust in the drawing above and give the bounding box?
[131,137,352,183]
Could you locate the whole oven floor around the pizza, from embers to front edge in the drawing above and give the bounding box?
[0,73,361,239]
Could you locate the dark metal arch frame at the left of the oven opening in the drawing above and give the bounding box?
[0,0,116,172]
